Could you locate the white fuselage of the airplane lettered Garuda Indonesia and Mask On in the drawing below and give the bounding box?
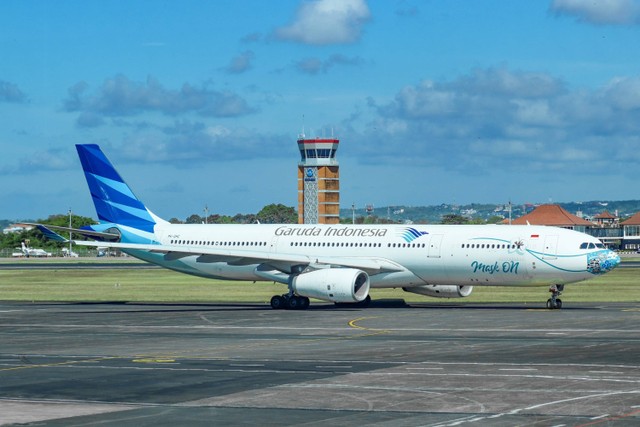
[125,223,619,288]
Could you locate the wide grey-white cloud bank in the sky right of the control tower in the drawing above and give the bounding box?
[345,67,640,175]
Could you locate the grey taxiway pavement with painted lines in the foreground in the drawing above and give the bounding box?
[0,301,640,427]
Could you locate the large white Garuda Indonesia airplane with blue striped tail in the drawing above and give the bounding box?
[40,144,620,309]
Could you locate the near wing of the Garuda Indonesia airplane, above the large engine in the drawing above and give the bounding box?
[74,240,405,274]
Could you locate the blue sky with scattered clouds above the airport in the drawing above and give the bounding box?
[0,0,640,220]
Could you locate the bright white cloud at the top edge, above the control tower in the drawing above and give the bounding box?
[274,0,371,45]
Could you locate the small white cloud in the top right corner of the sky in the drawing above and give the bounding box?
[551,0,640,25]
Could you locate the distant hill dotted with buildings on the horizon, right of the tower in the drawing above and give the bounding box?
[340,200,640,224]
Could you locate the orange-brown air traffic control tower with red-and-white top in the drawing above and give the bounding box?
[298,135,340,224]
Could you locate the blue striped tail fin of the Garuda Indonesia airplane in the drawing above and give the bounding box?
[76,144,161,233]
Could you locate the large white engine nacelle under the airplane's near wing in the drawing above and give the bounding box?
[292,268,370,302]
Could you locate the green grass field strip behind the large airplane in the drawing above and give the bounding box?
[0,262,640,305]
